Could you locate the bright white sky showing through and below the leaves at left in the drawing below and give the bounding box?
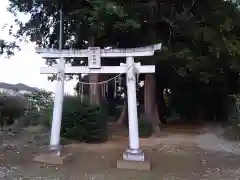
[0,0,76,94]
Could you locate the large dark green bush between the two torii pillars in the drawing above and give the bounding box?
[61,96,107,143]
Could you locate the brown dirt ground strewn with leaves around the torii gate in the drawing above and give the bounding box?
[0,124,240,180]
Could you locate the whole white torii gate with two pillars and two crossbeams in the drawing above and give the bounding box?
[36,44,161,161]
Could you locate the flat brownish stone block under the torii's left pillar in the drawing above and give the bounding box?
[33,153,72,165]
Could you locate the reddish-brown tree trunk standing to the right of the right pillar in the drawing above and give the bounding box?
[144,74,160,133]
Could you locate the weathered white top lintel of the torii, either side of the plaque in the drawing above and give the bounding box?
[36,43,162,59]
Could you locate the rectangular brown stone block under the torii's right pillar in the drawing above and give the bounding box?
[117,160,151,171]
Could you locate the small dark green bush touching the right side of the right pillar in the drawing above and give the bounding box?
[138,114,153,138]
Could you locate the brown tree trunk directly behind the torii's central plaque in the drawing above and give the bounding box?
[88,36,100,105]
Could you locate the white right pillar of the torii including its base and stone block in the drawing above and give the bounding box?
[117,57,151,170]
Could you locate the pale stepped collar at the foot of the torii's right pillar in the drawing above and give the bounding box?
[123,149,145,162]
